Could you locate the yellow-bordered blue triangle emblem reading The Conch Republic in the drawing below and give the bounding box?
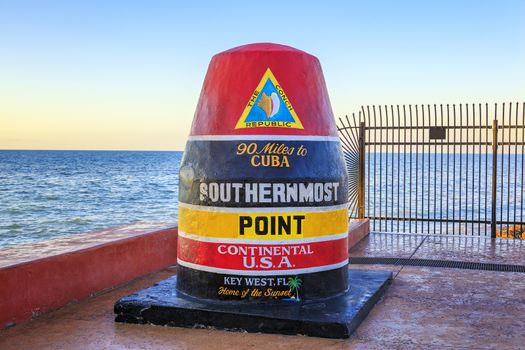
[235,68,304,129]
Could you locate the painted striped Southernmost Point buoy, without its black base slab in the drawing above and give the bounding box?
[177,44,348,301]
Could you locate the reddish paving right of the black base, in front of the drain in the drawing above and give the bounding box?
[351,267,525,349]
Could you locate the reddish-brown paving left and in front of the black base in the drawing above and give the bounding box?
[0,268,342,350]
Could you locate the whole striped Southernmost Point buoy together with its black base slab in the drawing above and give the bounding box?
[115,43,390,338]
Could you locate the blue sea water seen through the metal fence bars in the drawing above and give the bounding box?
[365,149,525,235]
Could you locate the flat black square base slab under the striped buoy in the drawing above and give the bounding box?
[115,269,392,338]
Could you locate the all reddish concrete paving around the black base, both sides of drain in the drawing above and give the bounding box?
[0,234,525,350]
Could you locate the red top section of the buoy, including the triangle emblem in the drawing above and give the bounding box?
[190,43,337,136]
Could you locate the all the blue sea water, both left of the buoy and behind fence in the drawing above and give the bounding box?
[0,151,525,247]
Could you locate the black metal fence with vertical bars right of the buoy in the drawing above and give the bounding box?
[339,103,525,236]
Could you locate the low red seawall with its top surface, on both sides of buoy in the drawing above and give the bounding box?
[0,220,369,329]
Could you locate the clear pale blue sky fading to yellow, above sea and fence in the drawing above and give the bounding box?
[0,0,525,150]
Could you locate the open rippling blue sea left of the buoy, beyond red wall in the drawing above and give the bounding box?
[0,151,182,247]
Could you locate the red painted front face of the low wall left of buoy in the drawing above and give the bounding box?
[0,228,177,329]
